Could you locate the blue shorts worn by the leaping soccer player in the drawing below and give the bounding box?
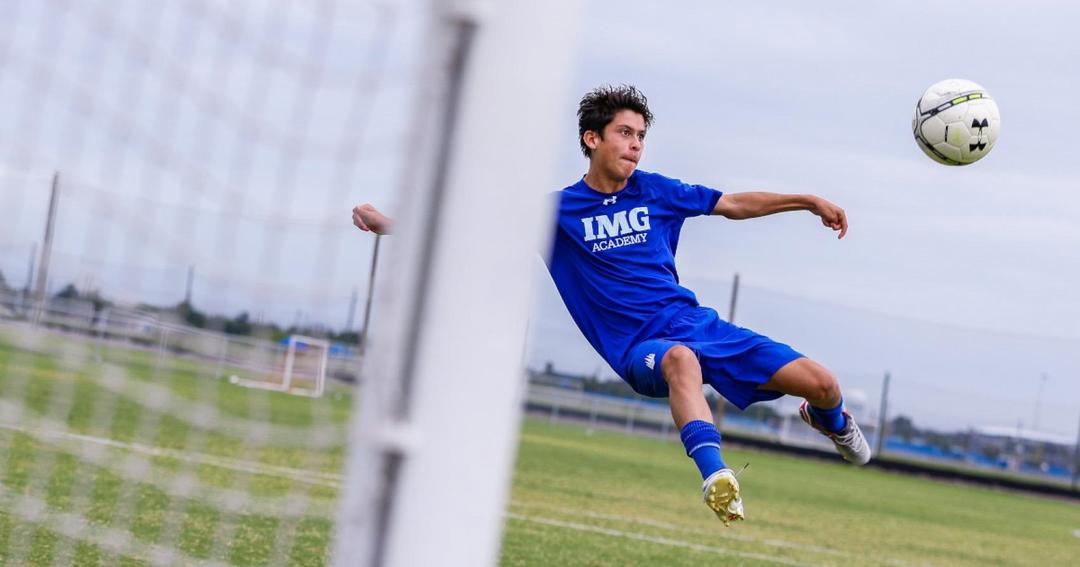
[622,307,802,409]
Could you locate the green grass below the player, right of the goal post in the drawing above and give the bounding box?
[502,421,1080,566]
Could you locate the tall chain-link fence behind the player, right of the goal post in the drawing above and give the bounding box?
[529,278,1080,487]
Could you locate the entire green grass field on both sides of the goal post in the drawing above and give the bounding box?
[0,324,1080,566]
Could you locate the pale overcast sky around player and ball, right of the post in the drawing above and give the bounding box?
[531,1,1080,438]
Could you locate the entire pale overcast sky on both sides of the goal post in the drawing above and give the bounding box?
[0,0,1080,438]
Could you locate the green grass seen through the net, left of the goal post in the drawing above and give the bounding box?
[0,332,352,566]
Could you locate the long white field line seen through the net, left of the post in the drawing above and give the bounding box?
[0,422,342,488]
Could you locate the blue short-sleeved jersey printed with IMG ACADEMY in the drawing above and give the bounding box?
[548,171,721,375]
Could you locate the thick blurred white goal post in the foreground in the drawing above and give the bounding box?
[335,0,577,566]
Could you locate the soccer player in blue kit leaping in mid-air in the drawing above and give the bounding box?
[353,85,870,525]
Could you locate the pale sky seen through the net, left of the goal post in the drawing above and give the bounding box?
[0,0,418,328]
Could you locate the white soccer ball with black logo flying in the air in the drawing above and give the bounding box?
[912,79,1001,165]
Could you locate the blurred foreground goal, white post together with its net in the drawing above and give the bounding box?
[0,0,572,566]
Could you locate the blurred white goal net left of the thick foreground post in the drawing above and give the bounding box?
[0,0,421,565]
